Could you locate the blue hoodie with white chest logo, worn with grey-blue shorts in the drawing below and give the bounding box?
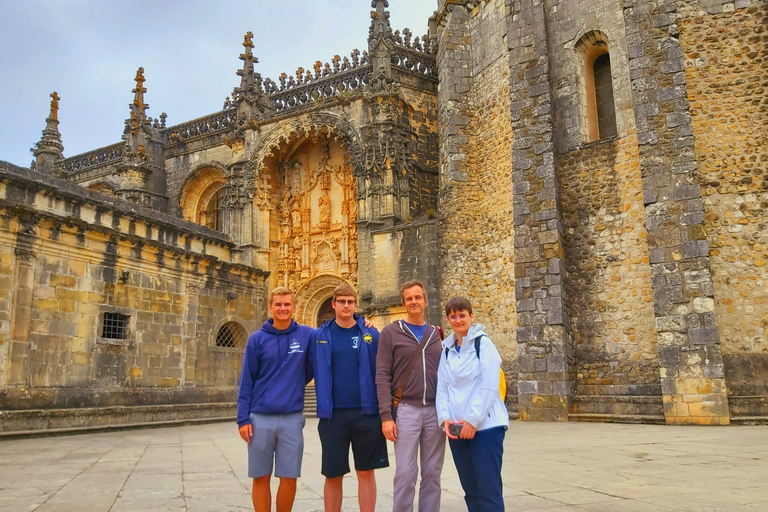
[237,319,312,427]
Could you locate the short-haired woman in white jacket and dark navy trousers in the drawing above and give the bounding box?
[435,297,509,512]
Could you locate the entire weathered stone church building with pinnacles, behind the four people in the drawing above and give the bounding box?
[0,0,768,431]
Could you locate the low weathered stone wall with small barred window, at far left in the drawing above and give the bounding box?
[0,164,266,409]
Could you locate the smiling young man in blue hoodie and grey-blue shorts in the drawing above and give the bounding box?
[237,287,312,512]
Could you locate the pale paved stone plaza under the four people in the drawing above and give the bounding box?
[0,419,768,512]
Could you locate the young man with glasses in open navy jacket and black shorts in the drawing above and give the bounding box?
[310,284,389,512]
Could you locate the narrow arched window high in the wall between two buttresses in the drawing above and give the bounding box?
[576,30,618,142]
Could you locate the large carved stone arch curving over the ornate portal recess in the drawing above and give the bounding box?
[246,112,365,190]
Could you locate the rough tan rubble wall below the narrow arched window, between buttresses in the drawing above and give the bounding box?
[559,135,661,415]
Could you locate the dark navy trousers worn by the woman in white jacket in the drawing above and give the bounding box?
[448,427,506,512]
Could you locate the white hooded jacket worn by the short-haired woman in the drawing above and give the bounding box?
[435,324,509,430]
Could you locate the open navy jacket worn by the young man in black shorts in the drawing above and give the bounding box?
[309,315,379,418]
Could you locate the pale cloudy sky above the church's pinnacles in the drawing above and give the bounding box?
[0,0,437,167]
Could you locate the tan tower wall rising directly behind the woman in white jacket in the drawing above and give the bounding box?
[440,0,517,388]
